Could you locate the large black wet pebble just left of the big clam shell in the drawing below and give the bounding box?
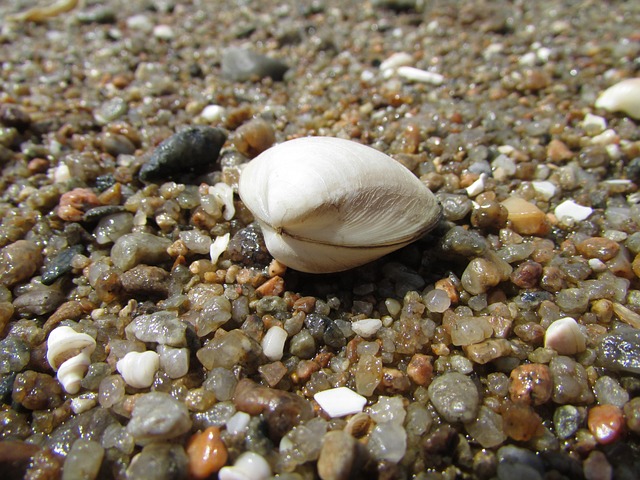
[139,126,227,182]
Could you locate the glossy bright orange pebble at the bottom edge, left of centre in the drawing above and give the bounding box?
[187,427,228,479]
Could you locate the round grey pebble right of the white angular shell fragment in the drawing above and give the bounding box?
[428,372,480,423]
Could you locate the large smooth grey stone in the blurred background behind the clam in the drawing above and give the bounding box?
[221,47,289,82]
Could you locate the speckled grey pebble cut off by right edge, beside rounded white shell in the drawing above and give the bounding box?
[596,328,640,373]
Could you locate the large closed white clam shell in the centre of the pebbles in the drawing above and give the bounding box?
[239,137,441,273]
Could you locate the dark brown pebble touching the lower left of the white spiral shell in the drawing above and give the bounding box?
[12,370,62,410]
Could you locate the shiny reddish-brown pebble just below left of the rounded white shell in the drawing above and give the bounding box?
[509,363,553,405]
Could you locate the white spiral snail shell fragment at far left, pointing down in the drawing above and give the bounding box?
[47,326,96,395]
